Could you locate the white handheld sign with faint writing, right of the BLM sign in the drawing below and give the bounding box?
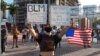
[49,6,70,26]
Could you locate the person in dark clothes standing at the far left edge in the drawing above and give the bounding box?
[1,25,7,54]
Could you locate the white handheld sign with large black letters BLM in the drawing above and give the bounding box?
[27,4,47,24]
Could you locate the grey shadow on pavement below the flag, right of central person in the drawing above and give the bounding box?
[55,44,84,56]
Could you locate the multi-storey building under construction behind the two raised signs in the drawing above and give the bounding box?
[14,0,79,30]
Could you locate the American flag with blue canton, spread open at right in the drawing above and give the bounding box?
[66,29,92,45]
